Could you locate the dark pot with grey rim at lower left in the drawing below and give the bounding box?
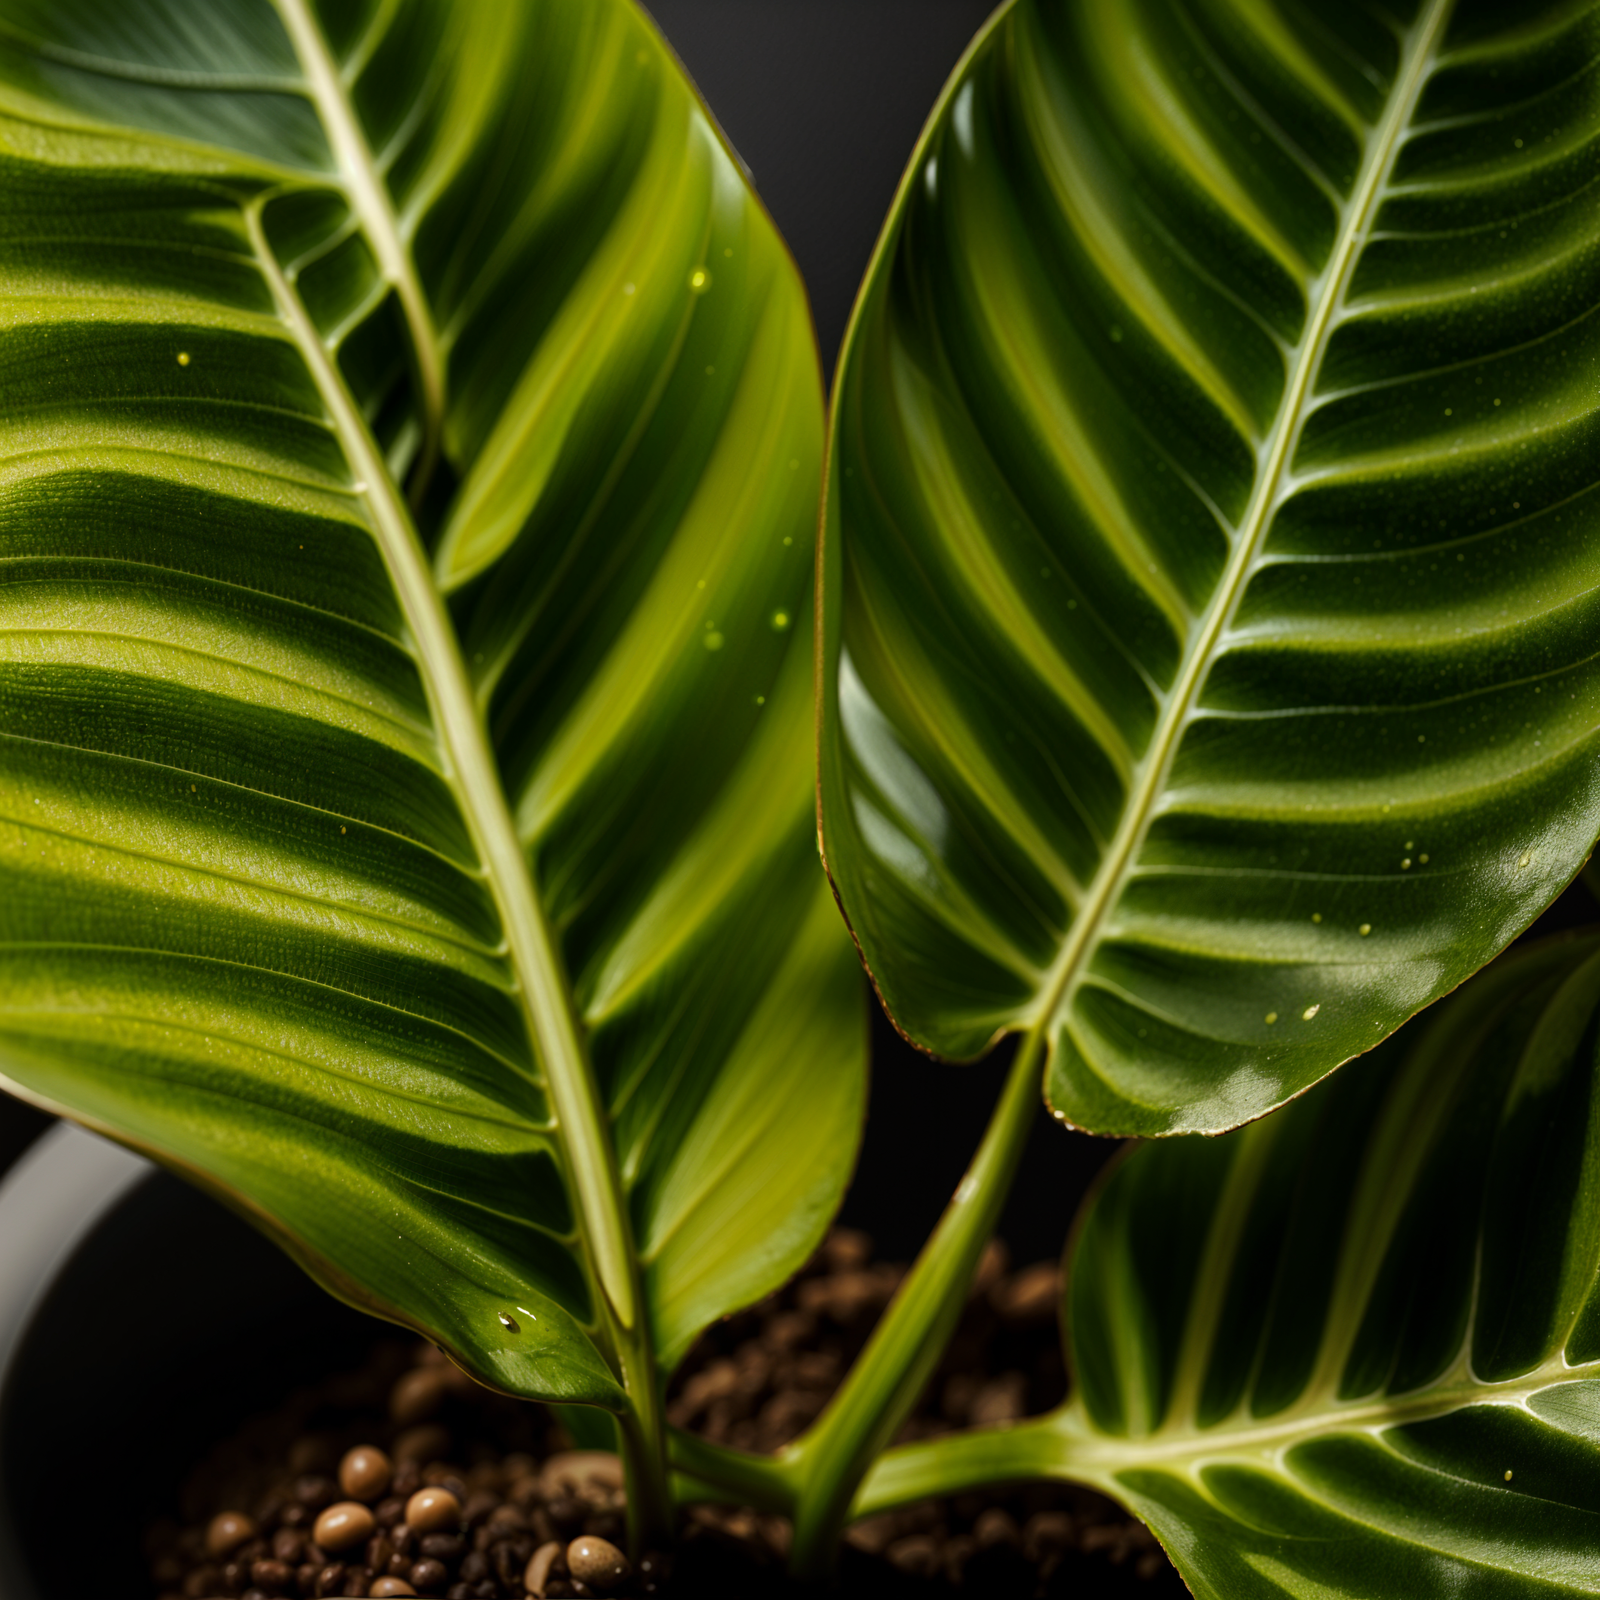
[0,1126,384,1600]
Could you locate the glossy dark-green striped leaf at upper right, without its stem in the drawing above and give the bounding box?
[822,0,1600,1134]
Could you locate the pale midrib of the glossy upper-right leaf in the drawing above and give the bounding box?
[1029,0,1454,1029]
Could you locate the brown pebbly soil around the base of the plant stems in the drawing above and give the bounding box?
[144,1229,1187,1600]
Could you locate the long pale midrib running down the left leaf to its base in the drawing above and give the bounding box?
[246,203,638,1330]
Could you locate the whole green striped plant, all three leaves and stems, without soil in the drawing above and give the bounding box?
[0,0,1600,1595]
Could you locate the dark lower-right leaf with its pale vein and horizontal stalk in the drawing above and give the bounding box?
[869,933,1600,1600]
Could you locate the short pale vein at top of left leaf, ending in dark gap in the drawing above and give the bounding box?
[274,0,445,492]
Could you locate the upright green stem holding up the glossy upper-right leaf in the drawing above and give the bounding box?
[781,1024,1045,1578]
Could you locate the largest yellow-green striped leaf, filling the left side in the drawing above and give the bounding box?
[0,0,864,1408]
